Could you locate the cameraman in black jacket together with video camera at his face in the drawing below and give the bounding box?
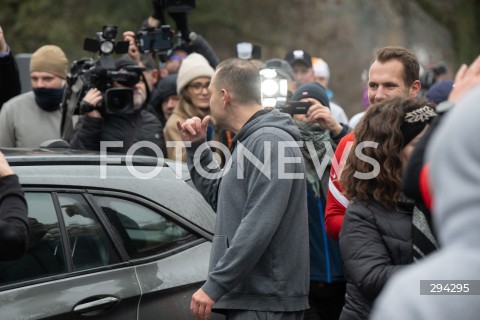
[70,58,166,156]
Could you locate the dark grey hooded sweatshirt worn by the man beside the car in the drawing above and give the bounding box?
[187,110,309,312]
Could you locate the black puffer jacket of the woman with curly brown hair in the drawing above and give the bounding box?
[340,202,413,320]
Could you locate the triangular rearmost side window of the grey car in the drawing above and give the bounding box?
[96,196,198,258]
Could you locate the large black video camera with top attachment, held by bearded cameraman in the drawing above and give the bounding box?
[68,25,144,114]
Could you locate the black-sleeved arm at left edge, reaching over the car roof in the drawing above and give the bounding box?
[0,152,29,261]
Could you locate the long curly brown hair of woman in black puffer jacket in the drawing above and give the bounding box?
[340,97,434,208]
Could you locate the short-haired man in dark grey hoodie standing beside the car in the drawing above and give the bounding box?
[177,59,309,320]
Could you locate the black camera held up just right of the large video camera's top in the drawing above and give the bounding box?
[136,25,173,53]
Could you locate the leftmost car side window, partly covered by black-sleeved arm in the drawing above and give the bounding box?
[0,192,67,285]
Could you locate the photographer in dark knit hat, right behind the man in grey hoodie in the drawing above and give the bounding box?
[291,82,348,320]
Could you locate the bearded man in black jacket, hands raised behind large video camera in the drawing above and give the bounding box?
[70,58,166,156]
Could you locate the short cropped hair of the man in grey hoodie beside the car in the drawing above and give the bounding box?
[213,58,262,104]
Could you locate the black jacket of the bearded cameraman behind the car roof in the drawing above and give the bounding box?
[70,110,167,156]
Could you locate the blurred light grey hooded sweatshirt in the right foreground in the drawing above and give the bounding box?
[371,86,480,320]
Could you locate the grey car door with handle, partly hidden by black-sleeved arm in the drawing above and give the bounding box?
[0,188,140,320]
